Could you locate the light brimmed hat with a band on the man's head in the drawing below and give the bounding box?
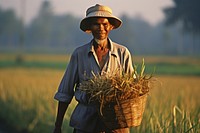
[80,4,122,32]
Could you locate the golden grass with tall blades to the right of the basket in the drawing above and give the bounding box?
[132,76,200,133]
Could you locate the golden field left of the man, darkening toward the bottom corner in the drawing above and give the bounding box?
[0,68,76,133]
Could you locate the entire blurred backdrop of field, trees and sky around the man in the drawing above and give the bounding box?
[0,0,200,133]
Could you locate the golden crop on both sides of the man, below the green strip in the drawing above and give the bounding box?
[0,68,200,133]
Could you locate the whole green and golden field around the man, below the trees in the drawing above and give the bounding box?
[0,54,200,133]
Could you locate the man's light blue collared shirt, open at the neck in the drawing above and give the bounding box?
[54,39,133,132]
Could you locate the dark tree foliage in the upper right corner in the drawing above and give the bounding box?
[164,0,200,33]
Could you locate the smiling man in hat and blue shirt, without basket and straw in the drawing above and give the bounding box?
[54,4,133,133]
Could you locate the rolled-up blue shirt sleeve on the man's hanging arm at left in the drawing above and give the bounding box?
[54,52,78,104]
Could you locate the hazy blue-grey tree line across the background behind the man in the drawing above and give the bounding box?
[0,0,200,55]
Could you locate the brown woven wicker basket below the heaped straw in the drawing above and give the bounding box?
[101,94,147,129]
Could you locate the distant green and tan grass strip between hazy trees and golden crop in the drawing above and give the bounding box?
[0,54,200,76]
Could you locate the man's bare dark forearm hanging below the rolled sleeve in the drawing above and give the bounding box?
[53,101,69,133]
